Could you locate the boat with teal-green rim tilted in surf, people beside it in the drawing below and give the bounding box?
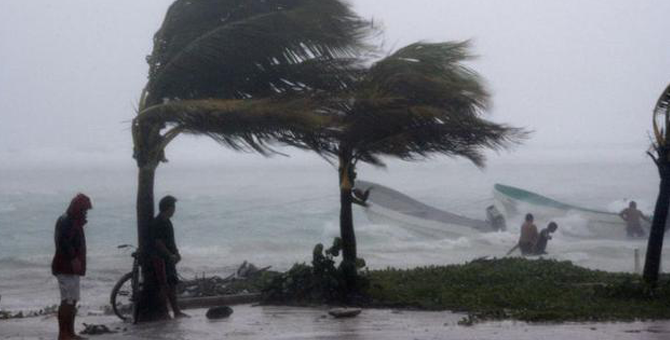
[493,184,649,239]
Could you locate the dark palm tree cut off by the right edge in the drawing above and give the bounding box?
[643,85,670,285]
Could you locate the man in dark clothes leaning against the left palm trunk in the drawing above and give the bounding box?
[147,195,188,318]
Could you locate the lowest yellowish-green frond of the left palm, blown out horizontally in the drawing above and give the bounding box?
[137,97,329,155]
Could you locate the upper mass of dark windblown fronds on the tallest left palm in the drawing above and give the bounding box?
[147,0,373,105]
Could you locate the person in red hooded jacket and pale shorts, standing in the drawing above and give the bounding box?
[51,194,93,340]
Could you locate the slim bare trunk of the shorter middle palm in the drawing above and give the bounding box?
[339,150,356,291]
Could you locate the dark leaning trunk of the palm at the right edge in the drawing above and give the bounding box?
[643,165,670,285]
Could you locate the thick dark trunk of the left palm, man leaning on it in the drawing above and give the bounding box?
[135,164,169,322]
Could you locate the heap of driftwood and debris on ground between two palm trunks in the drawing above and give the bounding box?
[177,261,271,298]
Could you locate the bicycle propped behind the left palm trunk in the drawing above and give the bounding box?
[109,244,142,322]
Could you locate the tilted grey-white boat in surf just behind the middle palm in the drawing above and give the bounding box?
[356,180,502,237]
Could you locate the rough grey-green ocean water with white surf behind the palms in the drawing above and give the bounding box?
[0,160,670,310]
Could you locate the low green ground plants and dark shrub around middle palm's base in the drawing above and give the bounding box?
[266,258,670,325]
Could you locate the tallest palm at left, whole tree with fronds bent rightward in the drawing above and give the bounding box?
[132,0,371,320]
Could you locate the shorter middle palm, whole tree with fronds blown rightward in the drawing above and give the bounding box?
[315,42,527,289]
